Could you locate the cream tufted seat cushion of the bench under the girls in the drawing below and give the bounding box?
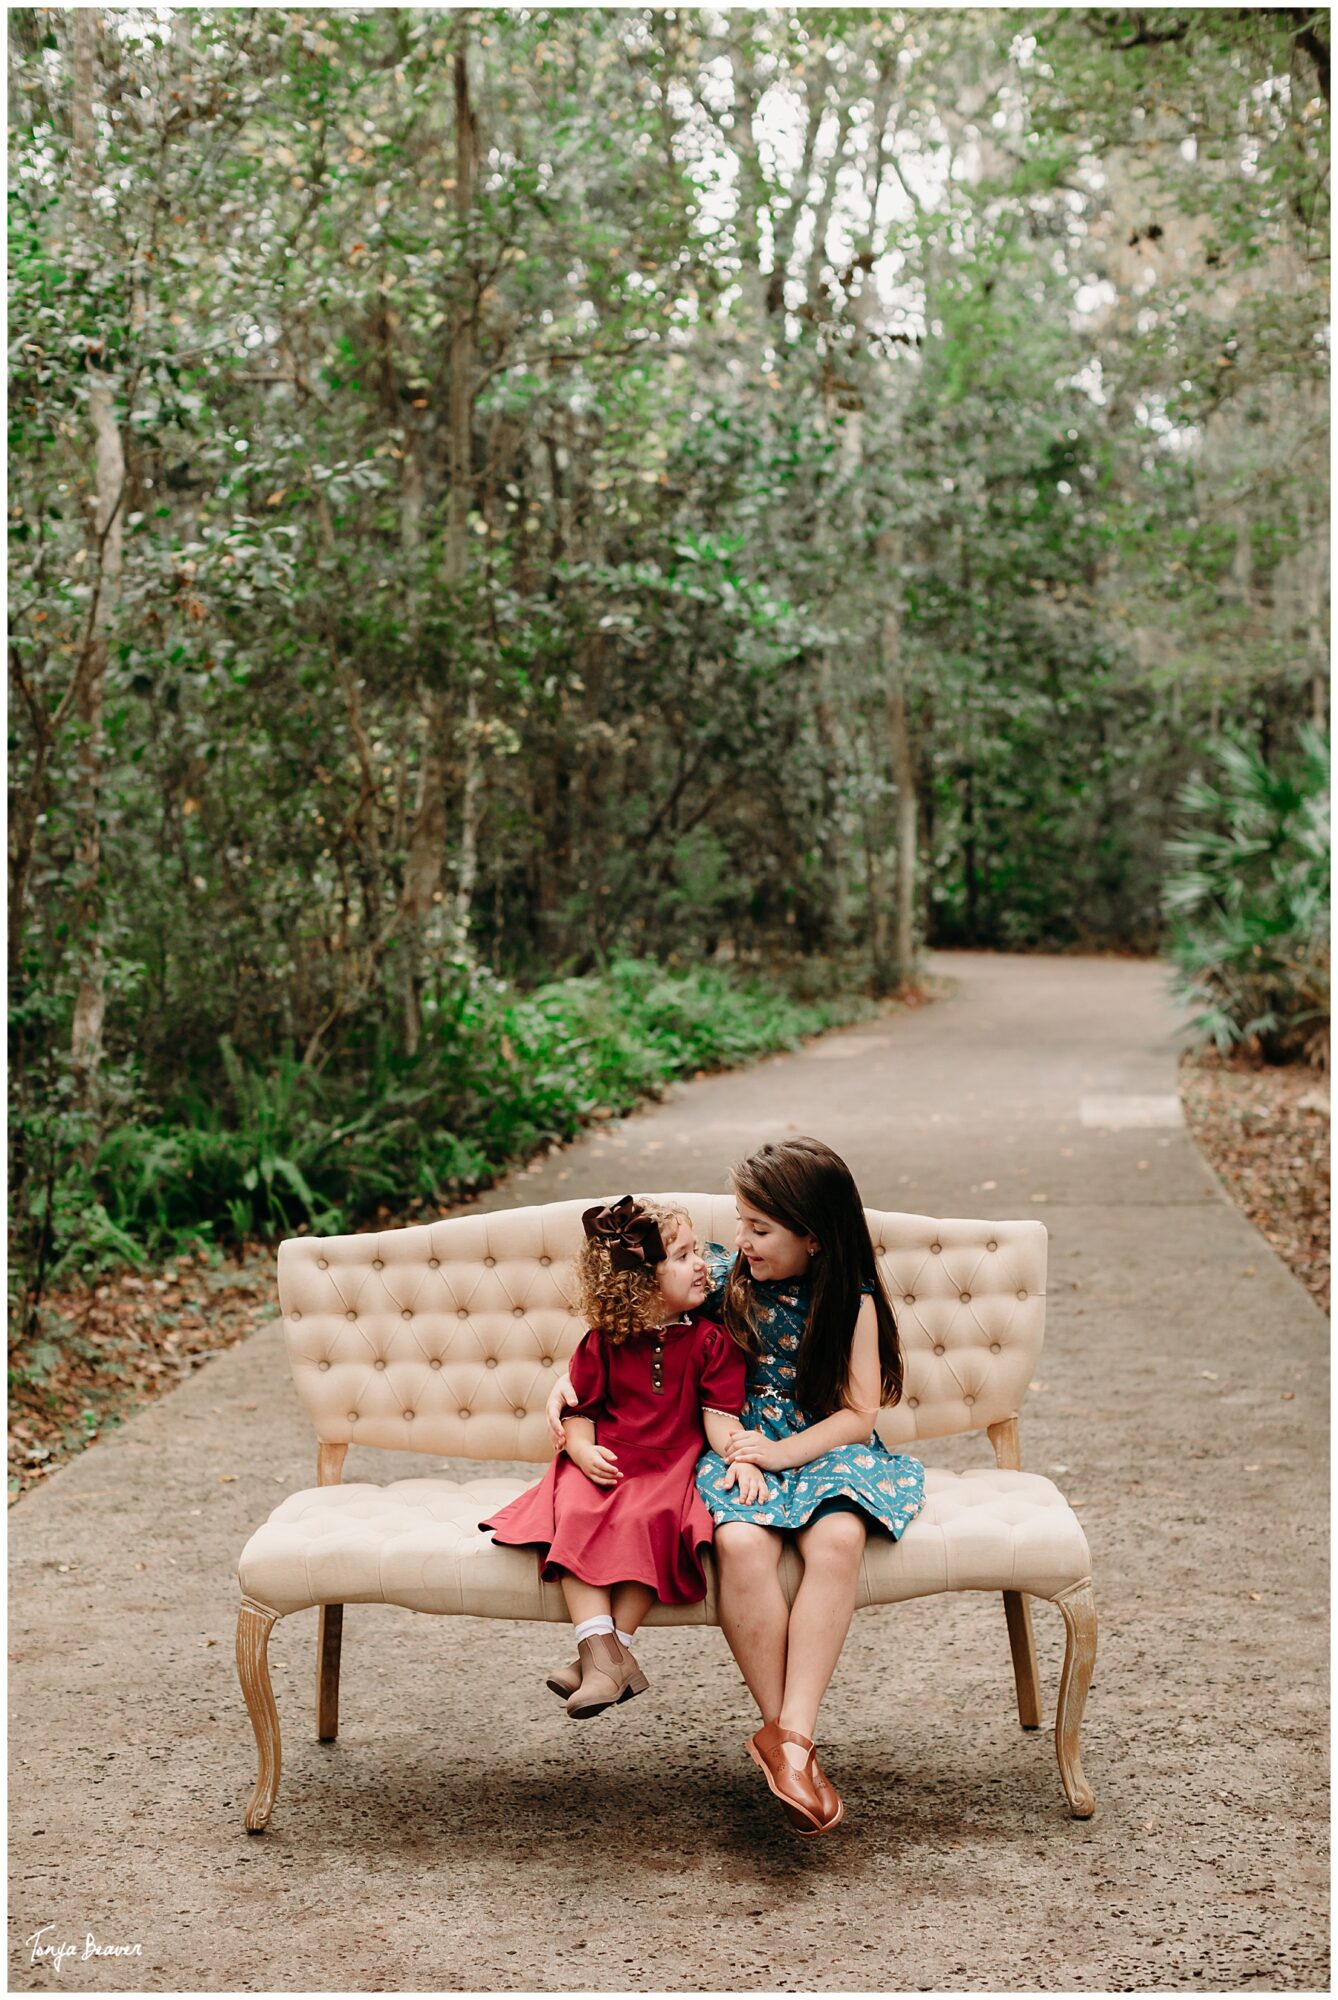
[240,1466,1092,1624]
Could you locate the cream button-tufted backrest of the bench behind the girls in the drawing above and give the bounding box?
[278,1194,1046,1462]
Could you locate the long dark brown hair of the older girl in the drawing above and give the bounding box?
[722,1138,902,1418]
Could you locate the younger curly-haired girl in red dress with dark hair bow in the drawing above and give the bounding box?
[480,1194,768,1718]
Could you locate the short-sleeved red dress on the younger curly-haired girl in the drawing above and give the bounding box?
[478,1320,746,1604]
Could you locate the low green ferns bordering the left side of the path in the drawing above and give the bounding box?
[7,958,862,1320]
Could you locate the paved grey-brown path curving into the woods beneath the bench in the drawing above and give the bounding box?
[10,954,1328,1992]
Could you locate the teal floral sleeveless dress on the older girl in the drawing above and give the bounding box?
[696,1244,924,1536]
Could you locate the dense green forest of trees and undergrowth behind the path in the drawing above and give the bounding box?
[8,8,1330,1424]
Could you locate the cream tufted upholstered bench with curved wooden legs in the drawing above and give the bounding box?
[236,1194,1096,1832]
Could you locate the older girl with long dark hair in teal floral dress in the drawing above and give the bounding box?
[550,1138,924,1836]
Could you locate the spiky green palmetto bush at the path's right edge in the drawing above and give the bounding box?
[1166,728,1330,1062]
